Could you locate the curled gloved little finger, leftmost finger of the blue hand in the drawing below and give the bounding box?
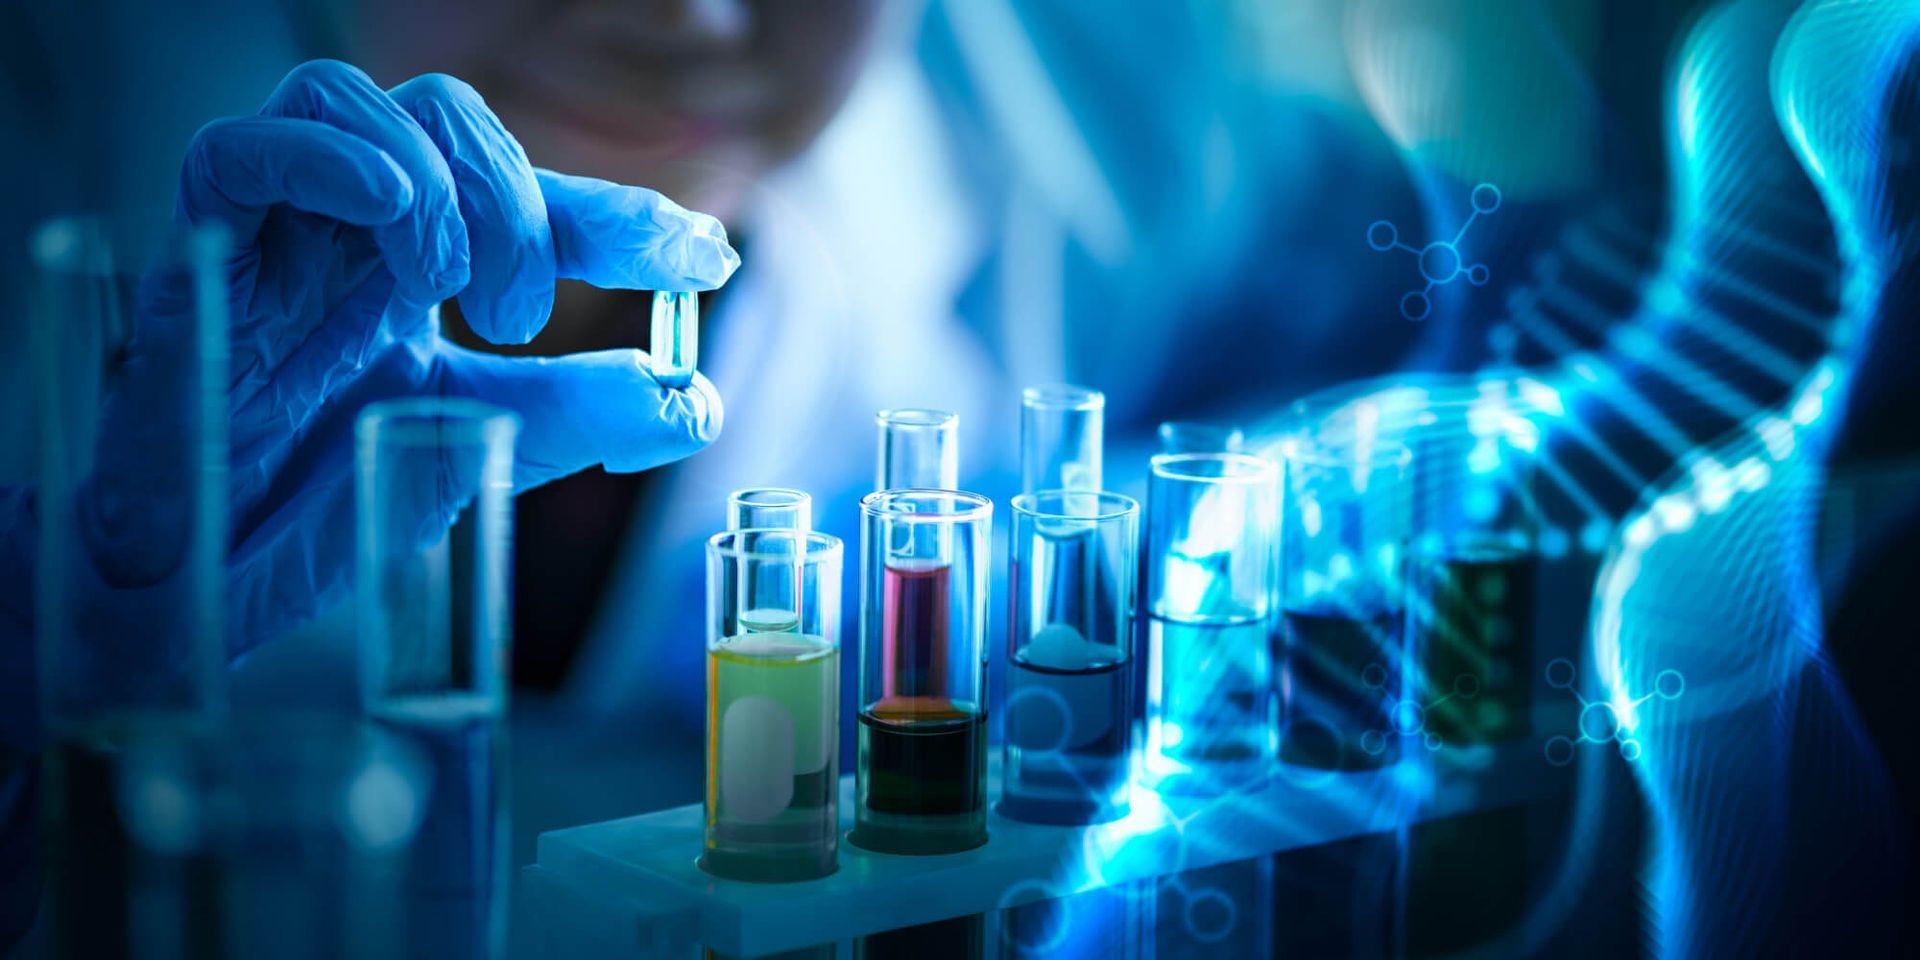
[179,117,413,246]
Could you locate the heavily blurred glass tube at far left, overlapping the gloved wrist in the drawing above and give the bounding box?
[28,215,232,956]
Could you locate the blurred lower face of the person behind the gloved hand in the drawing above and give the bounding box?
[346,0,879,219]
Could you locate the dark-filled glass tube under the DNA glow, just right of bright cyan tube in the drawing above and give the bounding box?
[1279,432,1425,770]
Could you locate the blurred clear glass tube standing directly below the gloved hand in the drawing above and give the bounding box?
[355,397,518,956]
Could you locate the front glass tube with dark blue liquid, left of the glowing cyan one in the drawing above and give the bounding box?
[1000,490,1140,824]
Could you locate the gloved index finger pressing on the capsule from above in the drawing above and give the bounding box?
[534,169,739,290]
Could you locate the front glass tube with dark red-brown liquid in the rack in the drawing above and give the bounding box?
[864,490,993,854]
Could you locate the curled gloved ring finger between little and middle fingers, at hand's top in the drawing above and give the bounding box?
[261,60,470,307]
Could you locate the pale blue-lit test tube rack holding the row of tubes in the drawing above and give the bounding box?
[518,743,1549,956]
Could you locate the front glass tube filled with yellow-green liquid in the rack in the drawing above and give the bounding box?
[701,530,841,881]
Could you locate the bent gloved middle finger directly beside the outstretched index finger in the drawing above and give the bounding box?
[388,73,553,344]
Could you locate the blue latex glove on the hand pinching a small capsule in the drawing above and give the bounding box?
[0,61,739,743]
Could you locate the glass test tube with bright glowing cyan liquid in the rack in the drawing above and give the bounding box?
[1146,453,1279,789]
